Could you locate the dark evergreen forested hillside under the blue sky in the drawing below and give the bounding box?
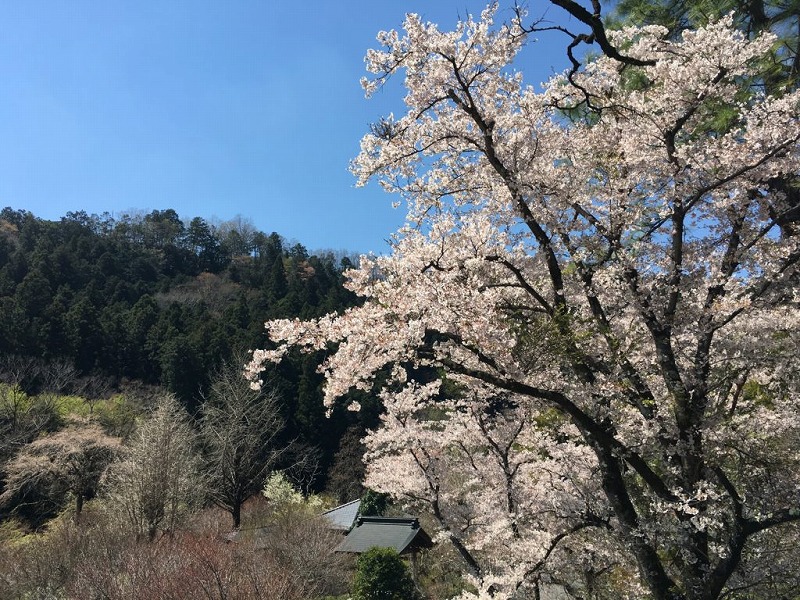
[0,208,374,493]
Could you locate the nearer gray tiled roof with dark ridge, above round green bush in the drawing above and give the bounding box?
[336,517,433,554]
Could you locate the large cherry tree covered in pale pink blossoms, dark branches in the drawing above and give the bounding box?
[248,0,800,599]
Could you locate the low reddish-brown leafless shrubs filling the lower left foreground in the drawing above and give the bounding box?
[0,503,349,600]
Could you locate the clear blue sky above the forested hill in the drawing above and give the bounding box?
[0,0,567,253]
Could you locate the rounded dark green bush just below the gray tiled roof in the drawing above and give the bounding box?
[352,548,417,600]
